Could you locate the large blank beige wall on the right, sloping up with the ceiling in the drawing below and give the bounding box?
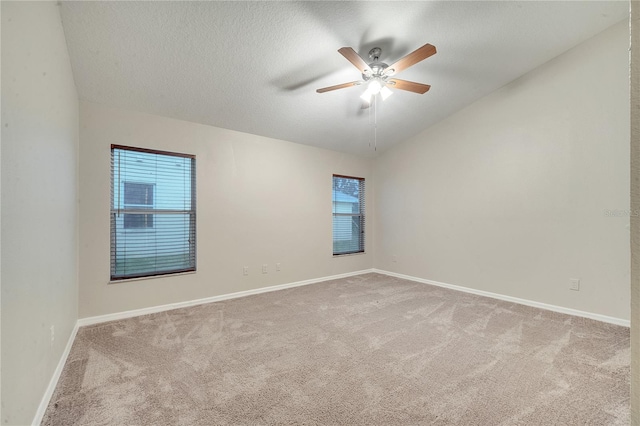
[374,22,630,319]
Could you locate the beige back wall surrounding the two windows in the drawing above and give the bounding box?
[79,103,374,318]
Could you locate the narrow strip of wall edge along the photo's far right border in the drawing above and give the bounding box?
[631,1,640,426]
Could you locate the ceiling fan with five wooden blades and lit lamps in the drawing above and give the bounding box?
[316,43,436,103]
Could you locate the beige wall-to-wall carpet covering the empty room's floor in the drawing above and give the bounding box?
[43,274,630,425]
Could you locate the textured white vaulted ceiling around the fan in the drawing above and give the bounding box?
[61,1,628,156]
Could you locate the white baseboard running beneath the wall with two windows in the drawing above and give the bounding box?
[78,269,373,327]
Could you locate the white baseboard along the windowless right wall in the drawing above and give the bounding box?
[373,269,630,327]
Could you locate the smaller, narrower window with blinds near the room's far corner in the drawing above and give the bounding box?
[333,175,364,255]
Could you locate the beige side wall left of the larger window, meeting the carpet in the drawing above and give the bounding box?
[1,1,78,425]
